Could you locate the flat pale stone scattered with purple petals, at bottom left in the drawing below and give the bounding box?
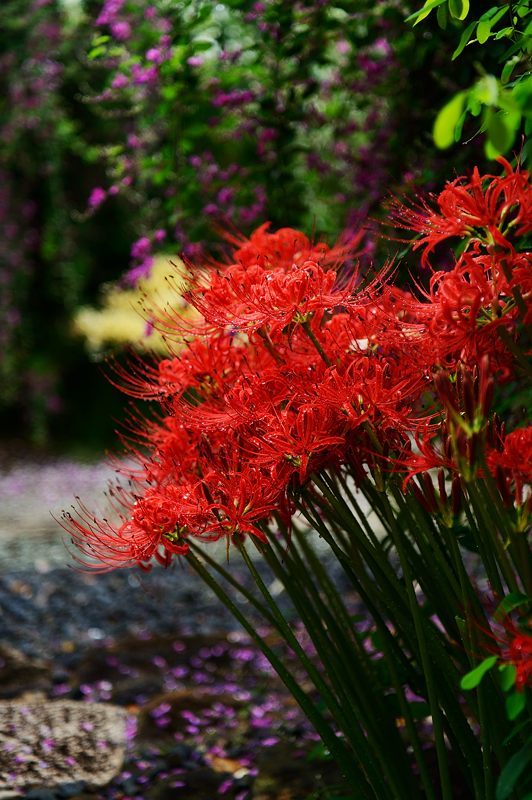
[0,700,127,797]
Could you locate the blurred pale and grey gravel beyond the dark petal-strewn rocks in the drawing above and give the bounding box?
[0,460,354,659]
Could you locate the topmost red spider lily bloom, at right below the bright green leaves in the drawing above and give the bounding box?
[393,158,532,267]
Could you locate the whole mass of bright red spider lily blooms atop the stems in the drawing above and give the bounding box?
[64,164,532,569]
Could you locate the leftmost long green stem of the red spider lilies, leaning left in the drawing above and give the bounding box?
[186,552,366,800]
